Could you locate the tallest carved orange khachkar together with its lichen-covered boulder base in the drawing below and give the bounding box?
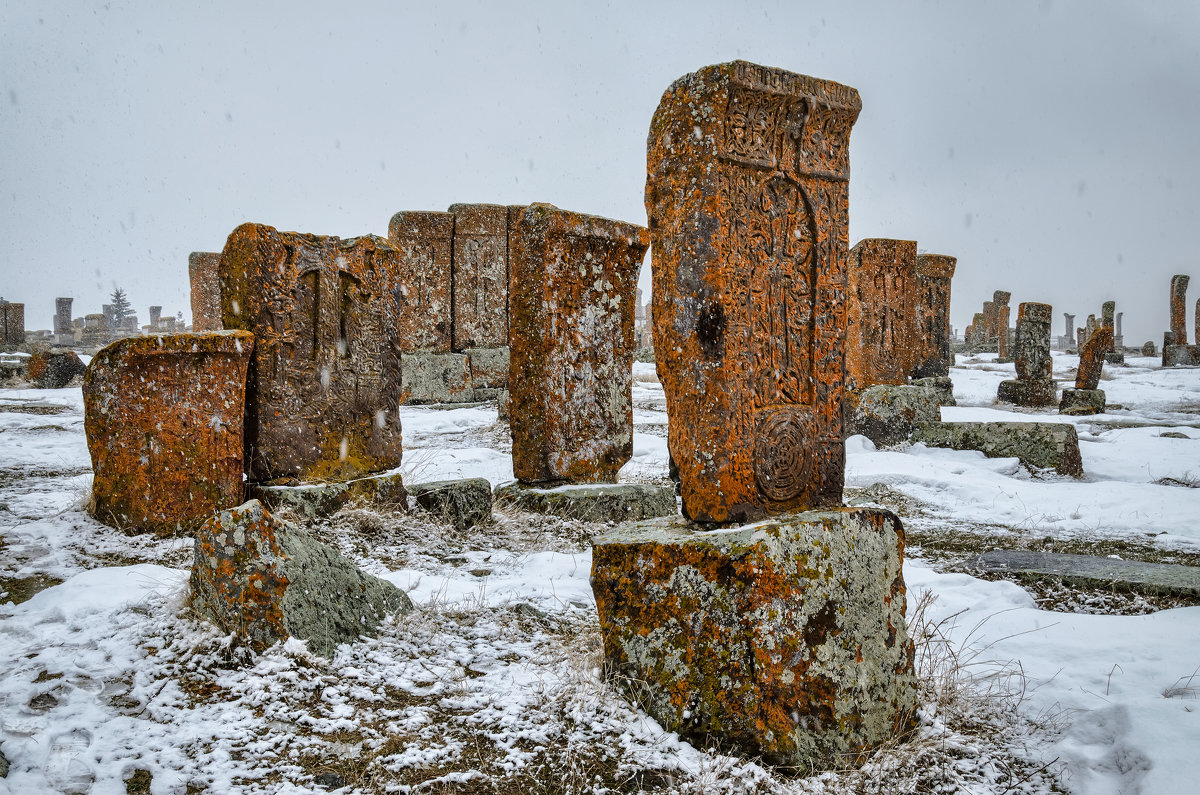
[592,61,916,767]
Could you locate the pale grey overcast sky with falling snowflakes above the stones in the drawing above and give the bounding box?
[0,0,1200,343]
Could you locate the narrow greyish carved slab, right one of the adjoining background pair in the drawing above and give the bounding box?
[450,204,509,351]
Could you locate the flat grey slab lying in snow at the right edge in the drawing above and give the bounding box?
[967,549,1200,597]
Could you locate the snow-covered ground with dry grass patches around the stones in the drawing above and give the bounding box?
[0,354,1200,794]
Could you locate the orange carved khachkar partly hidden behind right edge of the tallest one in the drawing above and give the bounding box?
[846,238,920,389]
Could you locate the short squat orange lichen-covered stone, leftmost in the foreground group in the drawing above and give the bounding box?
[83,331,254,536]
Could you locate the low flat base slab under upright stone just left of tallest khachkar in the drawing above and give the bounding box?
[496,483,677,522]
